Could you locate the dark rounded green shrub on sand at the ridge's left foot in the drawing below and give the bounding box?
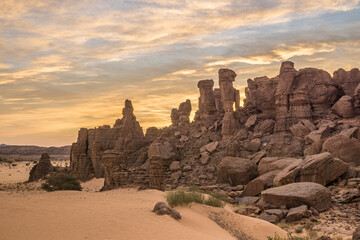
[41,173,82,192]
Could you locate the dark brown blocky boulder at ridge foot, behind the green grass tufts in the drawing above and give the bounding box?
[217,157,258,186]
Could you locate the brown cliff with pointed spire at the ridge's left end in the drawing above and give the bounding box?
[70,100,145,180]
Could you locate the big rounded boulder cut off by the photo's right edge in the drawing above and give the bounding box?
[322,134,360,166]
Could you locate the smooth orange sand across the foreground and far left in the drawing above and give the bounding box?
[0,164,286,240]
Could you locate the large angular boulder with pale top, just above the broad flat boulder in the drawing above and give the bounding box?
[300,152,349,185]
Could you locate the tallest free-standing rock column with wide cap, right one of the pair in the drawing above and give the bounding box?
[219,69,240,137]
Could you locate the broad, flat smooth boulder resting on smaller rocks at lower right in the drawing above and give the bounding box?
[261,182,331,212]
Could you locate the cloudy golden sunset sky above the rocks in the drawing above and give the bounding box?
[0,0,360,146]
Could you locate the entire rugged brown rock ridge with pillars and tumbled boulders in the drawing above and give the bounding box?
[67,61,360,237]
